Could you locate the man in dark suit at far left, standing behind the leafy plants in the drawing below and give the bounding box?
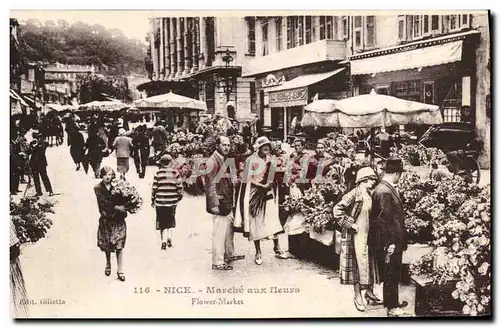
[29,132,54,196]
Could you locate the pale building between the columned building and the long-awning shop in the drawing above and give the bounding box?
[243,16,349,138]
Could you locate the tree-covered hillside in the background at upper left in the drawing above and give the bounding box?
[18,19,146,76]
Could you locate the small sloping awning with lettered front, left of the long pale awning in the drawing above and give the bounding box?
[266,68,345,107]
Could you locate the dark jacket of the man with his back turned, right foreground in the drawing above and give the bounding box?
[368,181,408,250]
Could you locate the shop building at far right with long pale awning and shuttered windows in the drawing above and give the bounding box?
[346,12,491,168]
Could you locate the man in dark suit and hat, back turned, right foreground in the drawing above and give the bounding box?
[368,159,408,317]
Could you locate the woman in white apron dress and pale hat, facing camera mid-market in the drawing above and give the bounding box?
[235,137,288,265]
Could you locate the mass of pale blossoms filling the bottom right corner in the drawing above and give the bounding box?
[411,179,491,316]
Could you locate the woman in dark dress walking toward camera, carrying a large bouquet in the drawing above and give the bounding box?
[94,166,127,281]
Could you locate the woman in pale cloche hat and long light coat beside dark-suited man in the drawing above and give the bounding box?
[333,167,382,312]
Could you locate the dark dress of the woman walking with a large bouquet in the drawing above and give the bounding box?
[94,182,127,252]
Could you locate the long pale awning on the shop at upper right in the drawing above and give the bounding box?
[351,40,463,75]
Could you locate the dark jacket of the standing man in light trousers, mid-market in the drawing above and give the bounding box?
[205,151,236,215]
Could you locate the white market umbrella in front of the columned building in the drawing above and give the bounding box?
[134,92,207,111]
